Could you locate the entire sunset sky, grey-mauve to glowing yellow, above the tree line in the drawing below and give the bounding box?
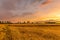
[0,0,60,22]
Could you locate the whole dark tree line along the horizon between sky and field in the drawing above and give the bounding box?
[0,21,56,24]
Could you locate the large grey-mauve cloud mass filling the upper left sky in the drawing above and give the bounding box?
[0,0,52,19]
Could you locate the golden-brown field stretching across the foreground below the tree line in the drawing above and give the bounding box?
[0,24,60,40]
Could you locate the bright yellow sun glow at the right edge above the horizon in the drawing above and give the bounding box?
[43,11,60,21]
